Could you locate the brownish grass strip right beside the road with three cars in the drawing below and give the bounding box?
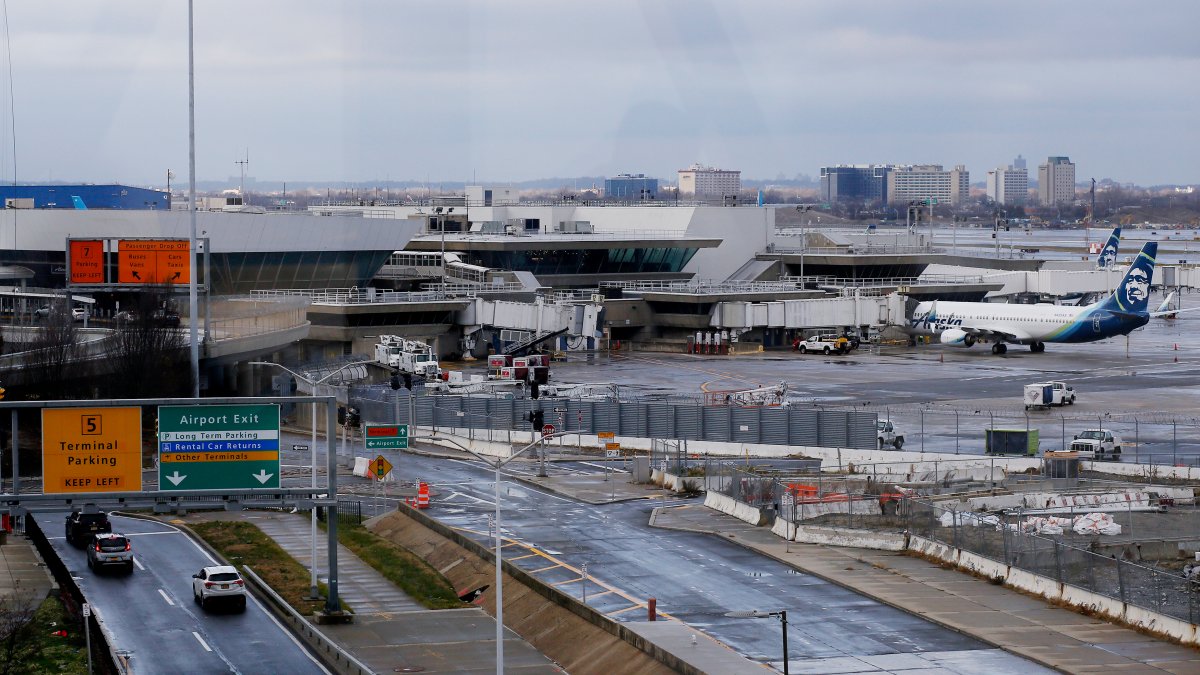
[191,520,350,616]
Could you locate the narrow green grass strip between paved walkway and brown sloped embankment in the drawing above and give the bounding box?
[331,519,463,609]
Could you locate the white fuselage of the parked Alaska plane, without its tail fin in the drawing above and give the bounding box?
[908,301,1150,345]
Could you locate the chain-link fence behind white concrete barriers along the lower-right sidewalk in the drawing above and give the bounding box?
[902,500,1200,623]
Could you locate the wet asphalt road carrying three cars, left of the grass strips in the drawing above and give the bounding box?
[36,512,329,675]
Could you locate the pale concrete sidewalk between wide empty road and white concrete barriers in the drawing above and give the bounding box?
[650,504,1200,674]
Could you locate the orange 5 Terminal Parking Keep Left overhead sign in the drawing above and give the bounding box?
[42,407,142,494]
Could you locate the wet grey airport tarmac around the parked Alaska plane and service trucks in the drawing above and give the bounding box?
[552,307,1200,465]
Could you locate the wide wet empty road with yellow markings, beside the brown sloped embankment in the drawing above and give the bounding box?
[391,455,1043,674]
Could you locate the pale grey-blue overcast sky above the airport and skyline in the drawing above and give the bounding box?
[0,0,1200,185]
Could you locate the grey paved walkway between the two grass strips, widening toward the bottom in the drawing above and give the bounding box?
[181,512,562,675]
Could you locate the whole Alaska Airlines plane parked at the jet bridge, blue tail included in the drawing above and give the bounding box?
[908,241,1158,354]
